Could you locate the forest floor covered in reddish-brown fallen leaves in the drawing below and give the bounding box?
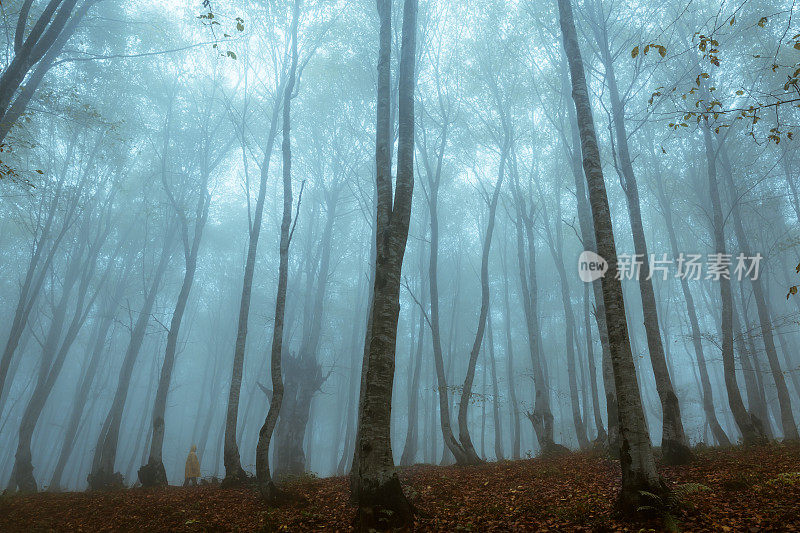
[0,444,800,532]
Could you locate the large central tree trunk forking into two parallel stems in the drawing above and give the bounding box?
[353,0,417,531]
